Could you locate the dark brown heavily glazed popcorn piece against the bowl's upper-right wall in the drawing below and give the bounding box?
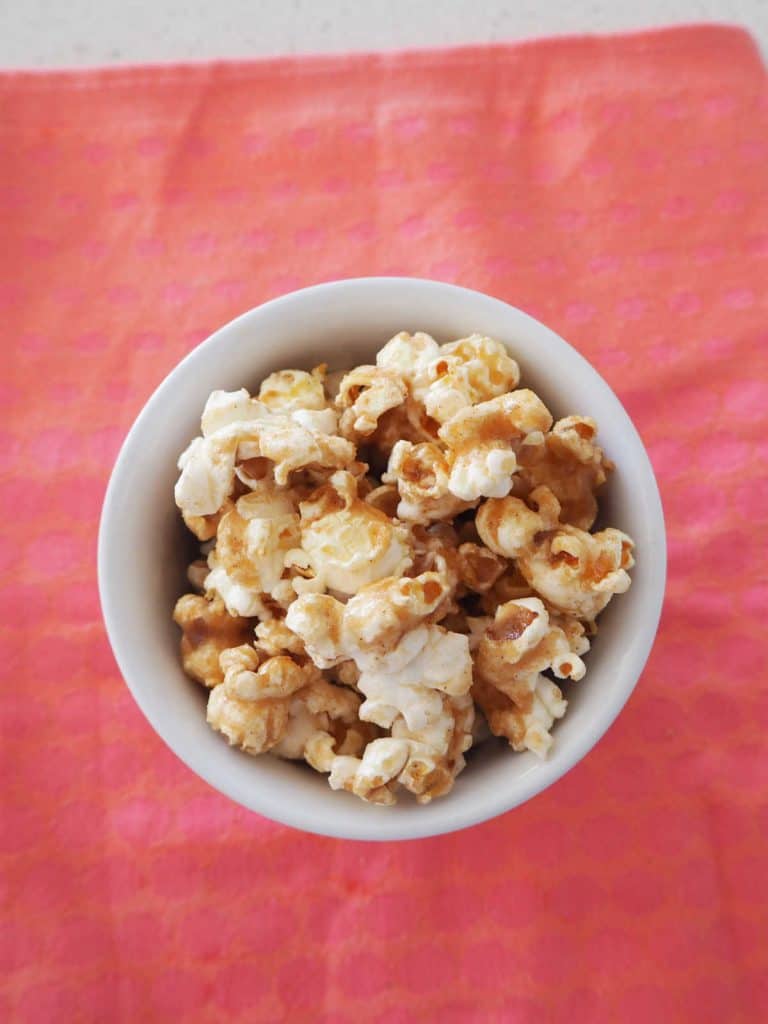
[519,416,612,529]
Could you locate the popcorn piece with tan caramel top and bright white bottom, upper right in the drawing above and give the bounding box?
[439,389,552,502]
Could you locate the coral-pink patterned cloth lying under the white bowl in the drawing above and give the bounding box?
[0,27,768,1024]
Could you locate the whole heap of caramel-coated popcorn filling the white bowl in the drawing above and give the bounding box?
[173,332,634,805]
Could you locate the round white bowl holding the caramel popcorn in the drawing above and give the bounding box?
[98,278,666,840]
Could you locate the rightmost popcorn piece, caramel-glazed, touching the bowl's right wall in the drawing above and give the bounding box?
[517,526,635,622]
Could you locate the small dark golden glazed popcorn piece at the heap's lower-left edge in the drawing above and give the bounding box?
[173,594,253,686]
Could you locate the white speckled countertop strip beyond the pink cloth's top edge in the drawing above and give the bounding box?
[0,0,768,68]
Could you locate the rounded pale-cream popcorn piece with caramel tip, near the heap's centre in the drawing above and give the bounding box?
[301,473,413,594]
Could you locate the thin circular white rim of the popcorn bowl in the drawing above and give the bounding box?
[97,275,667,842]
